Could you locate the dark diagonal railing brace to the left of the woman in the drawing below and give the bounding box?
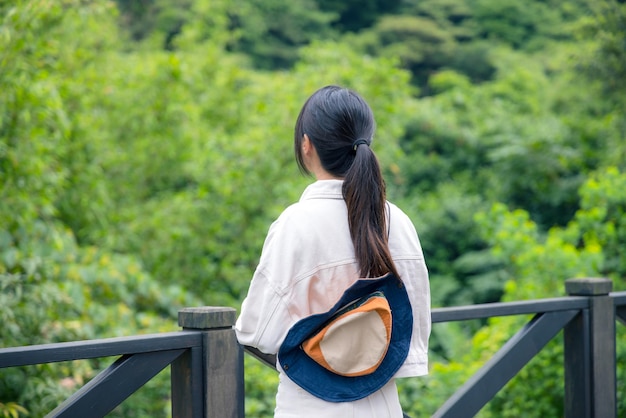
[46,348,186,418]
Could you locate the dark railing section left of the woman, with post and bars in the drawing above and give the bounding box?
[0,307,244,418]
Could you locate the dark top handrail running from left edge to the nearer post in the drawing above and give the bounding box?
[0,331,202,368]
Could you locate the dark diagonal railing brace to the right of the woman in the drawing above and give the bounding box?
[433,310,580,417]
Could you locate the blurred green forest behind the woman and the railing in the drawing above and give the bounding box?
[0,0,626,418]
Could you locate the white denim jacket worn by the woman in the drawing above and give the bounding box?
[235,180,431,377]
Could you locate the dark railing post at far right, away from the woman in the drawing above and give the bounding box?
[564,278,617,418]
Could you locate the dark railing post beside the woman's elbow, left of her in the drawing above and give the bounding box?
[172,306,244,418]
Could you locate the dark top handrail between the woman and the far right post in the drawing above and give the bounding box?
[431,296,589,323]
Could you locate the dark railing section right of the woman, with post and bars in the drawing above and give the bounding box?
[433,279,626,418]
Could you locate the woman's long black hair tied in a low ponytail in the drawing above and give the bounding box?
[294,86,399,277]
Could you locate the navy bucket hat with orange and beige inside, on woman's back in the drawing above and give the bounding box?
[278,273,413,402]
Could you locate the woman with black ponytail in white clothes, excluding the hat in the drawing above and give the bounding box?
[235,86,431,418]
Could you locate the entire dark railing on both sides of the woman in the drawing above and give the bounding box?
[0,279,626,418]
